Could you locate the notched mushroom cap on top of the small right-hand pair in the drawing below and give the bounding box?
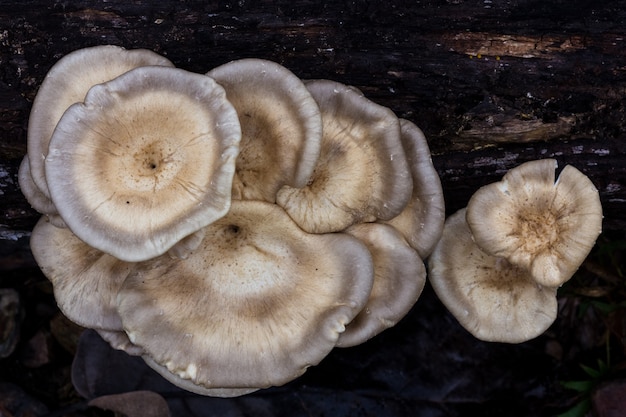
[467,159,602,287]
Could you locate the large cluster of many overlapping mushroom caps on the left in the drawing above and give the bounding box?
[19,46,445,396]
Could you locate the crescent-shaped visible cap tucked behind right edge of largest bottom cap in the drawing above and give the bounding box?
[337,223,426,347]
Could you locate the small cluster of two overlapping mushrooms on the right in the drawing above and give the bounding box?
[429,159,602,343]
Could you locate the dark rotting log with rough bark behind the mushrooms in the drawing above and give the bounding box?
[0,0,626,256]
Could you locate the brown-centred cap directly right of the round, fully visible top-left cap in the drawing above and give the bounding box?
[207,59,322,203]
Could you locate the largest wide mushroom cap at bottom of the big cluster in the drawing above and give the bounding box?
[118,200,374,389]
